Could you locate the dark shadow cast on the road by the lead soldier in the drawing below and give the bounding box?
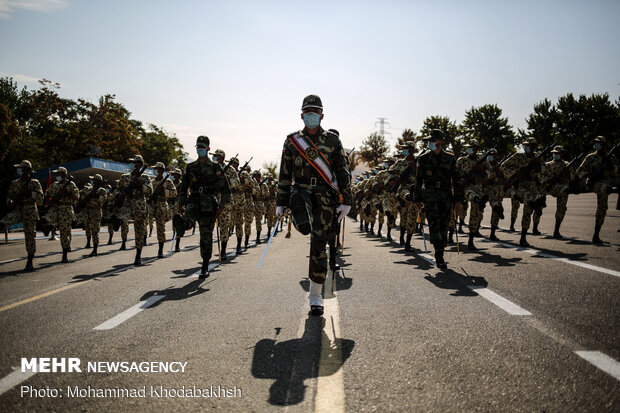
[252,316,355,406]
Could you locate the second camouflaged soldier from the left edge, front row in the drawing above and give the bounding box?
[43,166,80,263]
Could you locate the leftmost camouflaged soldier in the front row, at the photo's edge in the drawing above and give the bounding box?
[0,160,43,271]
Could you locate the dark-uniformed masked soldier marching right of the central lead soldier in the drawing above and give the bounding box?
[411,129,463,268]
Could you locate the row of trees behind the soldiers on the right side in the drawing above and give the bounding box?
[359,93,620,168]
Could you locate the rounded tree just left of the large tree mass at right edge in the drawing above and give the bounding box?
[461,105,517,156]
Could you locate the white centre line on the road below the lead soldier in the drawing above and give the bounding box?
[314,298,345,413]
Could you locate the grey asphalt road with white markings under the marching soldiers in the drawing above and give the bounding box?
[0,194,620,412]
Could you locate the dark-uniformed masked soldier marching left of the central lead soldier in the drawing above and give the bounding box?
[174,135,230,279]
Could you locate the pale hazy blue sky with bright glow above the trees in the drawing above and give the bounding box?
[0,0,620,168]
